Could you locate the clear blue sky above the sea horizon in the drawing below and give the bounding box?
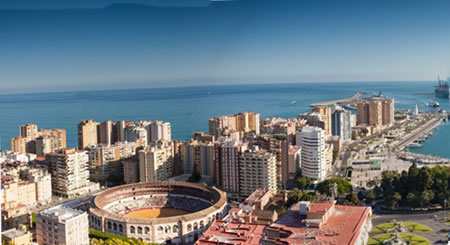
[0,0,450,93]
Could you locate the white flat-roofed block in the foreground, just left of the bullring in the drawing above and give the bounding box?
[36,206,89,245]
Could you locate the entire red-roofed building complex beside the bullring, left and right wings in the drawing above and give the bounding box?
[196,202,372,245]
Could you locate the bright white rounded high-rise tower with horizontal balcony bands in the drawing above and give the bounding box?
[300,127,327,182]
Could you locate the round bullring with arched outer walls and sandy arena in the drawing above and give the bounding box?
[89,182,227,244]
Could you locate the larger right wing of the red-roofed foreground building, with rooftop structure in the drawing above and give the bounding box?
[262,202,372,245]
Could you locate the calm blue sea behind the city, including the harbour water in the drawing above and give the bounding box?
[0,81,450,158]
